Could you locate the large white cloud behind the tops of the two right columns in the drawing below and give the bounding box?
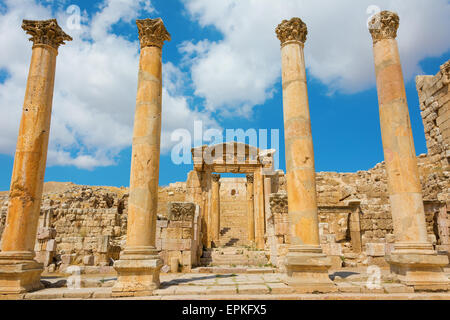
[180,0,450,116]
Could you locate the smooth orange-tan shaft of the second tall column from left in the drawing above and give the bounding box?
[127,46,162,249]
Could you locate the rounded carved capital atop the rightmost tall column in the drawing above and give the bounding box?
[369,11,400,43]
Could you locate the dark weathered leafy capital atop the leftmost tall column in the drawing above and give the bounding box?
[22,19,72,49]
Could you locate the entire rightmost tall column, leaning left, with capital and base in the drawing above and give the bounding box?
[369,11,448,290]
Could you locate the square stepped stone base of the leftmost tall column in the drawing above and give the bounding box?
[0,252,44,298]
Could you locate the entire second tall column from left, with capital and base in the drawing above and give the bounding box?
[112,19,171,296]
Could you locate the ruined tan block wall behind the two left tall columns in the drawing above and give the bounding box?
[0,182,192,271]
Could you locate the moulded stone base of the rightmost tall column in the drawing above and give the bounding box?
[386,250,450,291]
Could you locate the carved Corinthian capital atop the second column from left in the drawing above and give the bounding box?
[136,18,172,48]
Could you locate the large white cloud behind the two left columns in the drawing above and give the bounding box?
[0,0,216,169]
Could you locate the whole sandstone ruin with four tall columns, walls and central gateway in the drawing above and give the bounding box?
[0,11,450,297]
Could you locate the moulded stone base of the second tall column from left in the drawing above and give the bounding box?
[112,248,163,297]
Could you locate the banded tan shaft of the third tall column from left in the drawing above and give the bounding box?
[281,42,320,246]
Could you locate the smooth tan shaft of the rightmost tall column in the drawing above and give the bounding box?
[374,39,431,249]
